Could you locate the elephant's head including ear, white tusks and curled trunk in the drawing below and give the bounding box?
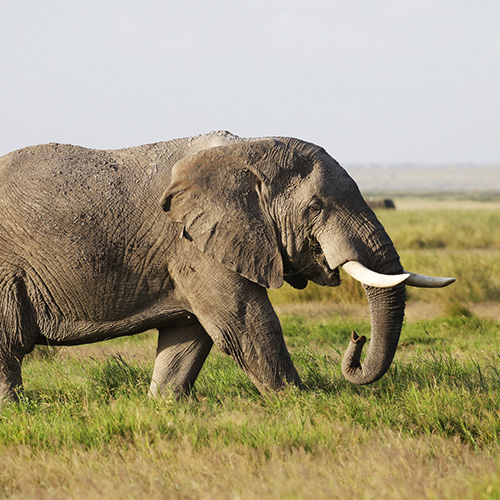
[162,139,454,384]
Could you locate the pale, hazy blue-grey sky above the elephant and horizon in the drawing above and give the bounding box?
[0,0,500,165]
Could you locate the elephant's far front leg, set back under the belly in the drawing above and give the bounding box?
[150,320,213,396]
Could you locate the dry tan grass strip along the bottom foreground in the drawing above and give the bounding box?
[0,430,500,500]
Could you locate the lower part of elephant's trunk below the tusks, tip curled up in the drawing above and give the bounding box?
[342,284,406,384]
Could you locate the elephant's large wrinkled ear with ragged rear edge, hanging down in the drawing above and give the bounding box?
[161,140,283,288]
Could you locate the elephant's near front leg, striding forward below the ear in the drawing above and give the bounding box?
[186,277,301,392]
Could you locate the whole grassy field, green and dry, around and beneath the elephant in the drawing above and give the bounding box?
[0,200,500,500]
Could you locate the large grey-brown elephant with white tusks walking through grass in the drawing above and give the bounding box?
[0,131,454,401]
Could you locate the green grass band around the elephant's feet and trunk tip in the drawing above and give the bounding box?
[0,317,500,449]
